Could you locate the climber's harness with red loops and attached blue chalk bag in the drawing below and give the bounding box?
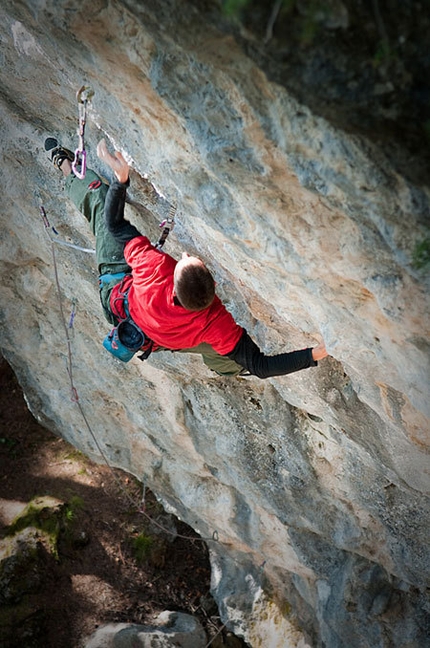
[99,273,154,362]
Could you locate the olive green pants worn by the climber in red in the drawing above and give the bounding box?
[66,169,243,376]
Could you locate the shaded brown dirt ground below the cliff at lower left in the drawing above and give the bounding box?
[0,358,249,648]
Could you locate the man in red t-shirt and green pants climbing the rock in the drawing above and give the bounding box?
[45,138,327,378]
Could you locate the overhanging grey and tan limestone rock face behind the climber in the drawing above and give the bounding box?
[0,0,430,648]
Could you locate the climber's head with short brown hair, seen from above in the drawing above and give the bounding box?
[173,252,215,311]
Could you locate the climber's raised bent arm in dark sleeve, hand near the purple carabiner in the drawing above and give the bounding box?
[97,139,141,245]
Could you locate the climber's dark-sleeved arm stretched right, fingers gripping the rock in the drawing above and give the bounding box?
[227,330,328,378]
